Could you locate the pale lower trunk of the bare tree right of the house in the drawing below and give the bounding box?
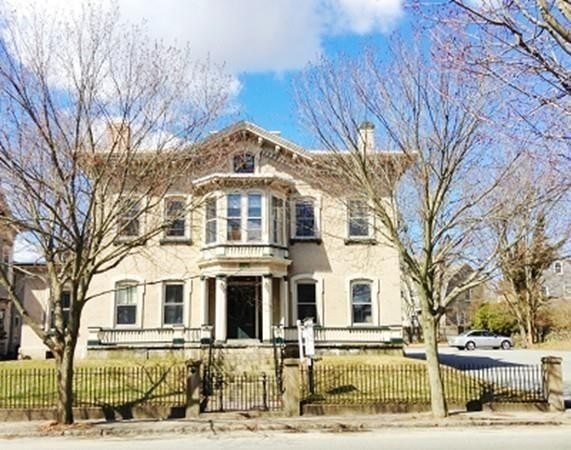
[422,311,448,418]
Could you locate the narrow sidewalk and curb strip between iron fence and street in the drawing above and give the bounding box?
[0,417,571,440]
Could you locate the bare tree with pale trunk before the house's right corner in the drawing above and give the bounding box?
[296,42,517,417]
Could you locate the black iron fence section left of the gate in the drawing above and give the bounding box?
[0,365,186,409]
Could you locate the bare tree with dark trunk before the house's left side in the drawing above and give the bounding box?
[0,5,229,424]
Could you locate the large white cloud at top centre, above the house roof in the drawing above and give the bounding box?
[8,0,403,73]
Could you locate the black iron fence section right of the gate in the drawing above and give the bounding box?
[302,364,545,404]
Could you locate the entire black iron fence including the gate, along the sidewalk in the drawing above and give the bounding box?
[0,363,546,412]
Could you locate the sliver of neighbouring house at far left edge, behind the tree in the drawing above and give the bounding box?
[0,195,16,359]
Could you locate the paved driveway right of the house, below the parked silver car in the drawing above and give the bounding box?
[405,346,571,403]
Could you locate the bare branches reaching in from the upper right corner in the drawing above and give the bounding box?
[434,0,571,145]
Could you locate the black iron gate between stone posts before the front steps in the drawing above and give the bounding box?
[200,371,282,412]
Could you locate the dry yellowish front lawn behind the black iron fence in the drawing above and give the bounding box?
[0,355,544,408]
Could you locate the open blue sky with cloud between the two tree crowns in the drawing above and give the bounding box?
[4,0,406,147]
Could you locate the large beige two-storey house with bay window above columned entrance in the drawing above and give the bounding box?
[16,122,402,357]
